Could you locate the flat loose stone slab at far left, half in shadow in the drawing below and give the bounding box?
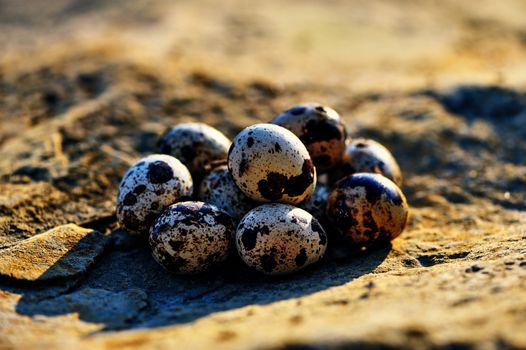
[0,224,107,283]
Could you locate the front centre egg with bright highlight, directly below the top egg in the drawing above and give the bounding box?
[236,203,327,275]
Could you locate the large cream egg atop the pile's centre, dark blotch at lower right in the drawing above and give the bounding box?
[228,124,316,204]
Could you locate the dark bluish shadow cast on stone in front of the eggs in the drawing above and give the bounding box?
[11,230,391,330]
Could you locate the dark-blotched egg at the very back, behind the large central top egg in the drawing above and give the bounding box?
[272,103,347,173]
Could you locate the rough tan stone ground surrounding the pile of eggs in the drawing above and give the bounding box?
[0,0,526,349]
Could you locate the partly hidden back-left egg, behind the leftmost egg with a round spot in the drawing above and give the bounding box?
[158,123,230,182]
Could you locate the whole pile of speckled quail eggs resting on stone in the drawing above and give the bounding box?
[116,103,408,275]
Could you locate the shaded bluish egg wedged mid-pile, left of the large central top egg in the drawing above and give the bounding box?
[198,165,258,223]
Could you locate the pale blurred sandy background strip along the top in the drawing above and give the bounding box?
[0,0,526,90]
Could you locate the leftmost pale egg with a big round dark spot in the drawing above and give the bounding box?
[116,154,193,235]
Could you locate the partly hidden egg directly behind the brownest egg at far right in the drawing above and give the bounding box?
[336,138,402,186]
